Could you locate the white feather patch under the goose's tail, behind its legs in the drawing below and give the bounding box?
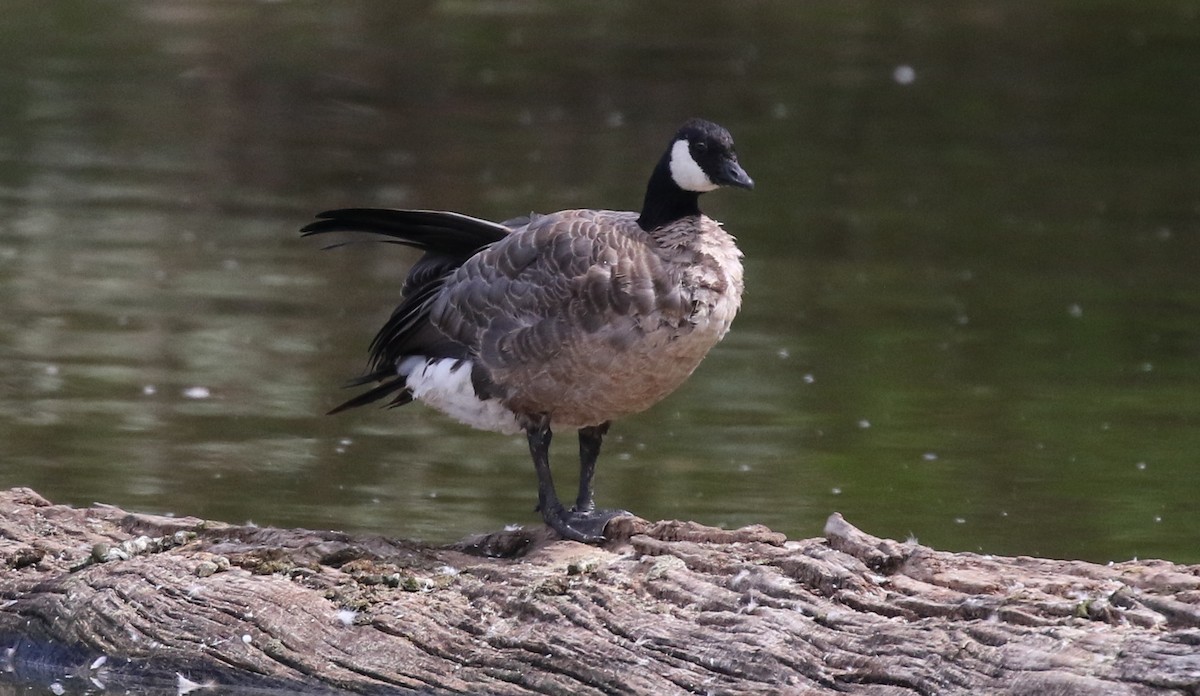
[398,355,522,434]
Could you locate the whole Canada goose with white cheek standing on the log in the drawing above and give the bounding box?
[301,119,754,542]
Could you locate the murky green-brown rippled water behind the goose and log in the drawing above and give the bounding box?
[0,0,1200,578]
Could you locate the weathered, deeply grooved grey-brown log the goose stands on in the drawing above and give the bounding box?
[0,488,1200,695]
